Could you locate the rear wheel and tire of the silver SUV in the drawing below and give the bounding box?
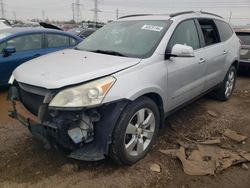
[212,66,236,101]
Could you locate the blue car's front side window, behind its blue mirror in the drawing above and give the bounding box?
[7,34,42,52]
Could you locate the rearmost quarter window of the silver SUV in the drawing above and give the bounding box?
[215,20,233,42]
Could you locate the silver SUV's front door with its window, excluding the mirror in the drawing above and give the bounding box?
[167,19,206,110]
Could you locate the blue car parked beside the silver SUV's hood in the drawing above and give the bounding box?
[0,28,82,86]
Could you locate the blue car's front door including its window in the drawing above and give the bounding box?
[0,33,46,85]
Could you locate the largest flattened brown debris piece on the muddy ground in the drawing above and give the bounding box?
[160,139,250,176]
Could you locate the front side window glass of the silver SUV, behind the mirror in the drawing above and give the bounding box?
[168,20,200,50]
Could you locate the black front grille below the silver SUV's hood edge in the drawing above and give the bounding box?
[19,83,48,116]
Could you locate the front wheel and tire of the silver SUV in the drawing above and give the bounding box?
[110,97,160,165]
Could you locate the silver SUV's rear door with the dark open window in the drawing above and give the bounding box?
[197,19,228,90]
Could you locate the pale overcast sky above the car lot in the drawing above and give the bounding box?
[3,0,250,25]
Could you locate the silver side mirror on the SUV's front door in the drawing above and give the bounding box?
[166,44,194,57]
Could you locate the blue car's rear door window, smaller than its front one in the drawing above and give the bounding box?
[47,34,70,48]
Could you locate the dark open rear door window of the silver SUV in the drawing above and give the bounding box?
[198,19,220,46]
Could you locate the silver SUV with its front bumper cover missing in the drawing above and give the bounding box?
[9,11,240,165]
